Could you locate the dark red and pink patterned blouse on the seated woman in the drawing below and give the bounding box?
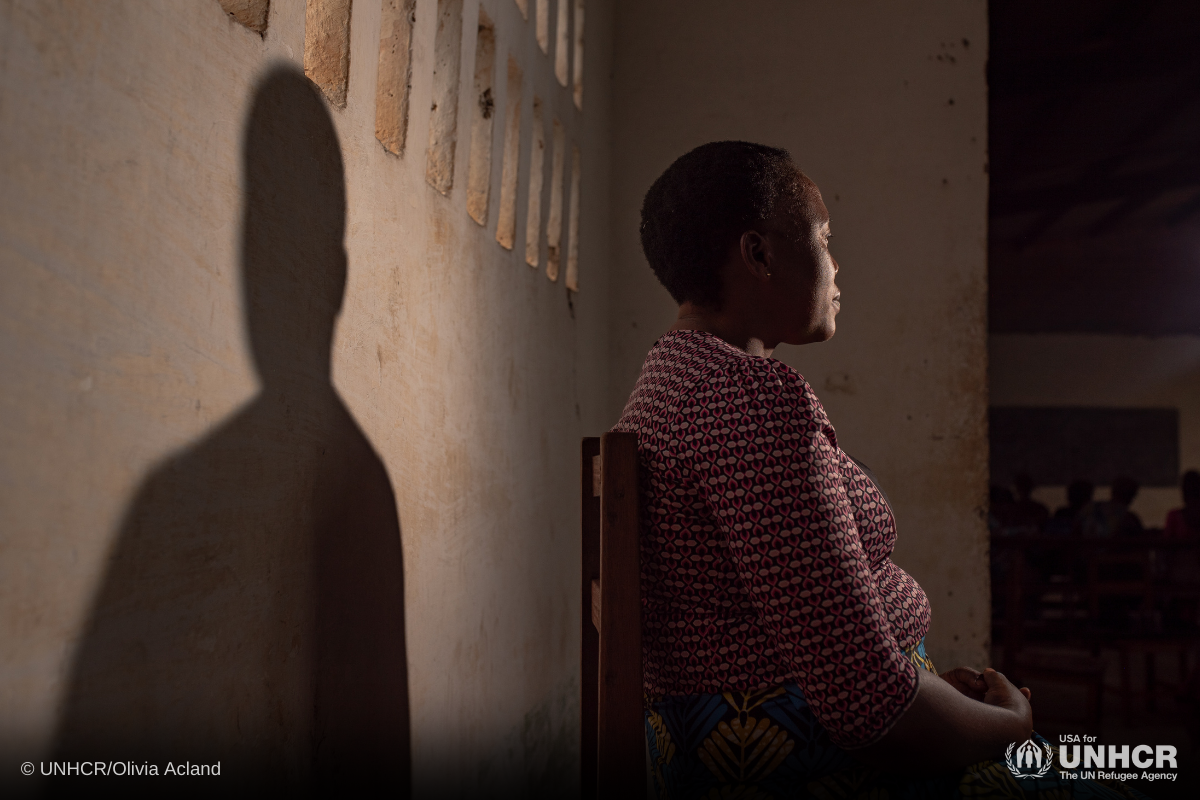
[614,331,929,748]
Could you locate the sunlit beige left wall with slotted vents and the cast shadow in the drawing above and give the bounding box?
[0,0,611,796]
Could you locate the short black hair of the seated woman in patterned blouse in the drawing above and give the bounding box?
[641,142,806,307]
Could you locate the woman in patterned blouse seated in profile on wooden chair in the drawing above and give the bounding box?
[616,142,1142,798]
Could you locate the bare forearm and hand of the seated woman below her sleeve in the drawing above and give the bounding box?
[851,669,1033,772]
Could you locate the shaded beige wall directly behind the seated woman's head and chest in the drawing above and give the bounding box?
[611,0,989,667]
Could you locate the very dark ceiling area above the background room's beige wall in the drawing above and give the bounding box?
[988,0,1200,336]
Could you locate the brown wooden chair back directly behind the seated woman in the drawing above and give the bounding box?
[580,432,646,799]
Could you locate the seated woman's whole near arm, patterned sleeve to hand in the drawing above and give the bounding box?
[683,363,1031,770]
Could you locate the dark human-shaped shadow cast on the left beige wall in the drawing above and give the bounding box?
[52,68,410,796]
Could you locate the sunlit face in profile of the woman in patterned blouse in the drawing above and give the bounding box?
[767,176,841,344]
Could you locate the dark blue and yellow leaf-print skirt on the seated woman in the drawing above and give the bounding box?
[646,639,1145,800]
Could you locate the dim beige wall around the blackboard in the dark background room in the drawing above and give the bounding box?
[988,333,1200,528]
